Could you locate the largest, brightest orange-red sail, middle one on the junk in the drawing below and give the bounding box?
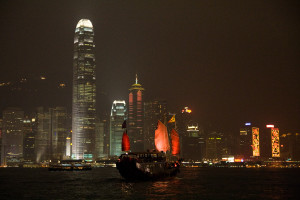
[155,120,170,152]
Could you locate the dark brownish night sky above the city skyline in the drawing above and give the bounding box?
[0,0,300,132]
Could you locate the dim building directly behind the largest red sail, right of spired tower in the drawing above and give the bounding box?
[144,99,168,150]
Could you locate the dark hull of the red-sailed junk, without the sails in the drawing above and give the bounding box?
[116,158,180,180]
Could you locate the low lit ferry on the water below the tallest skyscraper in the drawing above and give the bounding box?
[48,159,92,171]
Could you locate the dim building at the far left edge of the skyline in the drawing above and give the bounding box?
[1,107,24,166]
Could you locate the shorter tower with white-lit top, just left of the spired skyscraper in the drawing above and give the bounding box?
[110,100,126,156]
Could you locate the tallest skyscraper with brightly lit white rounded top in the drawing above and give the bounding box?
[72,19,96,161]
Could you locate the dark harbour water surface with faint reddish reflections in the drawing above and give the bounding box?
[0,168,300,200]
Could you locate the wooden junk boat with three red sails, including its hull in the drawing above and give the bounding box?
[116,121,181,180]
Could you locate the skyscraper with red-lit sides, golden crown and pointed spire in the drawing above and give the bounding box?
[127,75,144,151]
